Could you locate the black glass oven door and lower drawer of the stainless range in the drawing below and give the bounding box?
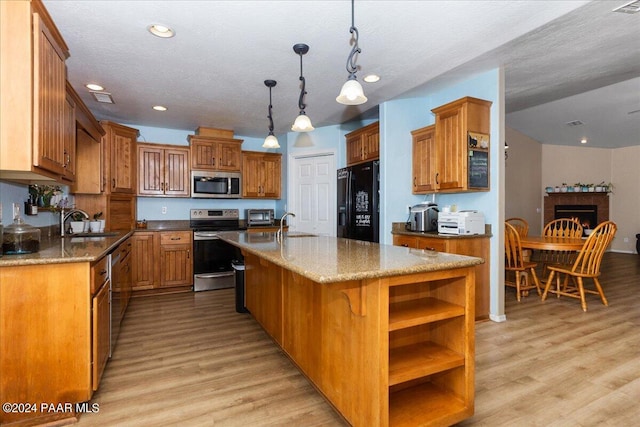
[193,231,242,292]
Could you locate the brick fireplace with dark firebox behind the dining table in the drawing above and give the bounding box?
[544,192,609,232]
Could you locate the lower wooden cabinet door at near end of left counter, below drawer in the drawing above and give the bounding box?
[91,280,111,391]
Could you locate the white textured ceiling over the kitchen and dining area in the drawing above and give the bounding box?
[44,0,640,147]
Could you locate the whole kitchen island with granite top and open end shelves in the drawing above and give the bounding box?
[219,232,483,426]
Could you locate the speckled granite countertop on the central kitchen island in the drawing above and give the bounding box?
[219,231,484,283]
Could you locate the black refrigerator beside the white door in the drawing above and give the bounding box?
[337,160,380,243]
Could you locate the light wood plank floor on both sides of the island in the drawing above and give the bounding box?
[79,254,640,427]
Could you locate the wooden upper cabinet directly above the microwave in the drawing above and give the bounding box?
[189,135,242,172]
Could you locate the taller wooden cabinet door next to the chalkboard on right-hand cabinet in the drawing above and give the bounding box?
[436,108,467,190]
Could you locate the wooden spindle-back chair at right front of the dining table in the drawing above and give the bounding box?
[542,221,618,311]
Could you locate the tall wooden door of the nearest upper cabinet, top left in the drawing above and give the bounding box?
[33,13,66,176]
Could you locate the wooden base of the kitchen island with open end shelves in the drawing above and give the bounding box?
[245,254,475,427]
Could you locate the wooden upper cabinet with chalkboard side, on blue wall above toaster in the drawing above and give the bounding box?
[412,97,491,194]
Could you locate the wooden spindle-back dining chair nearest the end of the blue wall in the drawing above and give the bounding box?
[504,222,541,301]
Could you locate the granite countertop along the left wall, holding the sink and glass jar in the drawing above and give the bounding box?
[0,231,133,267]
